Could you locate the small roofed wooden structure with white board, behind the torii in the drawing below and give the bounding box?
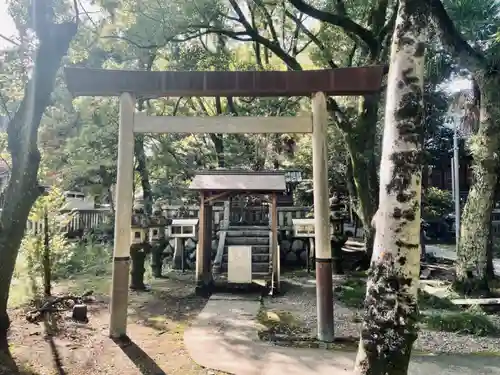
[189,170,286,289]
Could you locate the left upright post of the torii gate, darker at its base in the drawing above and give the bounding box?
[109,93,135,338]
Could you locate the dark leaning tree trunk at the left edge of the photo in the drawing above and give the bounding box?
[0,15,77,353]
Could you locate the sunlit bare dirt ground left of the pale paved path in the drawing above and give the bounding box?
[6,274,229,375]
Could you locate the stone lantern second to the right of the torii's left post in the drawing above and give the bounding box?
[149,205,168,277]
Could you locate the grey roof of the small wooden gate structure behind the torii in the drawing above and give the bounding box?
[189,170,286,192]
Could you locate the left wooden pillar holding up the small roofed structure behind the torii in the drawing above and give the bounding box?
[196,191,212,291]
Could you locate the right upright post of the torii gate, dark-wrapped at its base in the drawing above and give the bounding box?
[312,92,334,342]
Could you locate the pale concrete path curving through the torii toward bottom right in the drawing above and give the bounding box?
[184,295,500,375]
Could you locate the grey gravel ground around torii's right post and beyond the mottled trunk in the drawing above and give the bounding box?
[265,277,500,354]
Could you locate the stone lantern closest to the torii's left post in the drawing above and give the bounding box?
[130,203,150,290]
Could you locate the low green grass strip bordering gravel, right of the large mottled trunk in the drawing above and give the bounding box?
[422,311,500,336]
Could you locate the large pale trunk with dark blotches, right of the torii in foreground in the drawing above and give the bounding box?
[355,0,429,375]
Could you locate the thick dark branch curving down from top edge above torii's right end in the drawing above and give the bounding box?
[289,0,380,56]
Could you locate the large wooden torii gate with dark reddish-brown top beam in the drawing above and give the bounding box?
[65,66,384,342]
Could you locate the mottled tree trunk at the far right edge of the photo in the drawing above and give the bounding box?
[455,75,500,295]
